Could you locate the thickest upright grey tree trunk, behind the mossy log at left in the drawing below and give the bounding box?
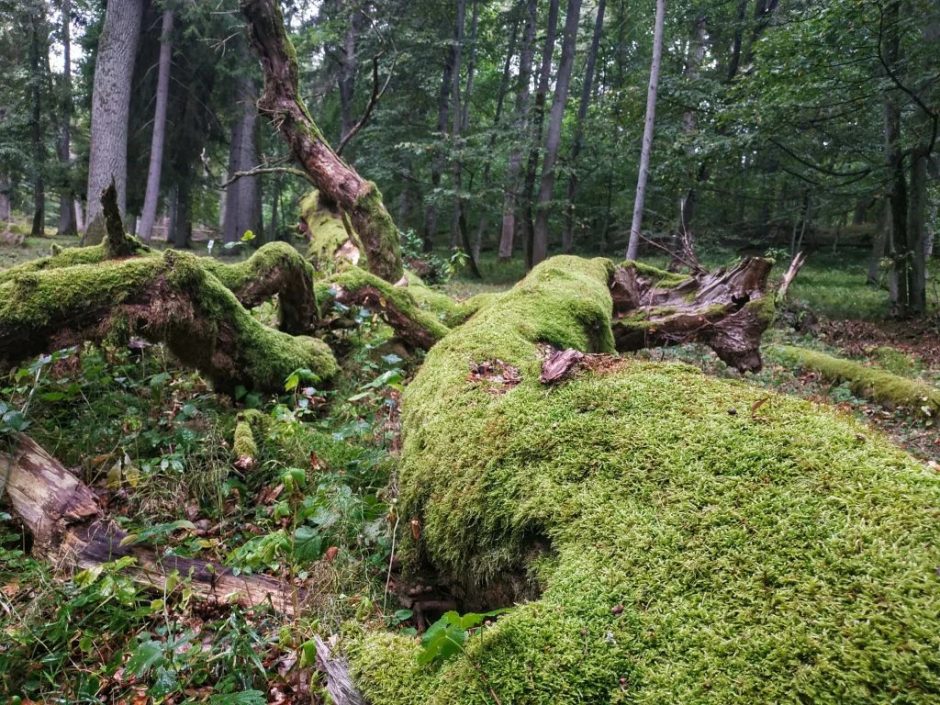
[84,0,144,244]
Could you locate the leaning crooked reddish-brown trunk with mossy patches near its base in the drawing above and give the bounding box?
[241,0,404,282]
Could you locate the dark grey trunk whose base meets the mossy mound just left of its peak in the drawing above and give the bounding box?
[532,0,581,265]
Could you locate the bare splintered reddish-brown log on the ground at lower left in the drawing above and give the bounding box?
[0,436,304,615]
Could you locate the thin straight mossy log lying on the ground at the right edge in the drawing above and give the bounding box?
[767,345,940,416]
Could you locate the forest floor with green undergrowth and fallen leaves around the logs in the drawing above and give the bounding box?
[0,232,940,705]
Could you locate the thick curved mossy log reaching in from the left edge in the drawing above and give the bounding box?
[0,251,337,393]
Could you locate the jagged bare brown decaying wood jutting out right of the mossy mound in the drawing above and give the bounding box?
[611,257,773,372]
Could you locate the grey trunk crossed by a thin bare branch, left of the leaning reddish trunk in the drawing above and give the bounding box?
[222,78,261,242]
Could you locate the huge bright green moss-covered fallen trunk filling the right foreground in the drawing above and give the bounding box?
[341,257,940,705]
